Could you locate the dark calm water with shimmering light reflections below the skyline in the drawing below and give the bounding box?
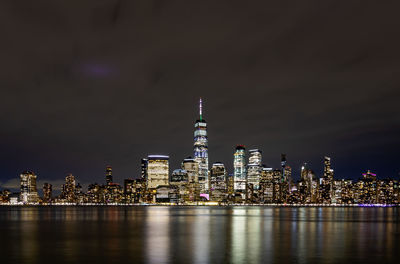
[0,206,400,264]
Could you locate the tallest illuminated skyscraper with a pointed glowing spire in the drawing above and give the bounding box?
[193,98,209,192]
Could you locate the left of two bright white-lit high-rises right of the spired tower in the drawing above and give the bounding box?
[233,145,247,194]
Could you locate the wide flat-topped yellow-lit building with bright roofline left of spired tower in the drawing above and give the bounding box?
[147,155,169,189]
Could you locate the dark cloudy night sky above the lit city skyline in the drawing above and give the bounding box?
[0,0,400,188]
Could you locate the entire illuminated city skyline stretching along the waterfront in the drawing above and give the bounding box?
[0,99,400,205]
